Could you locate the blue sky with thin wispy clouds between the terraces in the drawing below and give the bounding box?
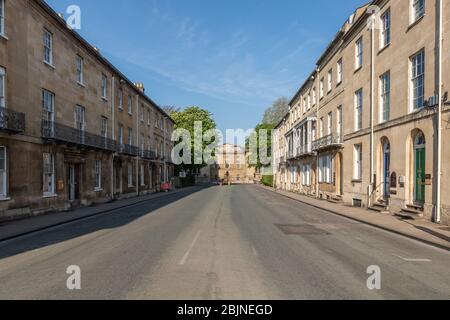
[47,0,366,130]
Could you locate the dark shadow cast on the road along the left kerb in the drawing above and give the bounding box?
[0,186,210,259]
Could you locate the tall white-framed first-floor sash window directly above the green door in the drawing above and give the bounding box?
[411,50,425,110]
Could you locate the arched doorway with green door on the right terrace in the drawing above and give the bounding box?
[413,132,426,205]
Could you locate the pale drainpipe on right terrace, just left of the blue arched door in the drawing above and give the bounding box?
[368,14,376,207]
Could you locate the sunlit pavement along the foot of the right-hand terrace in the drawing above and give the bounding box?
[258,185,450,250]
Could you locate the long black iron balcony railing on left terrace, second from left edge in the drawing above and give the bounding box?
[42,120,116,152]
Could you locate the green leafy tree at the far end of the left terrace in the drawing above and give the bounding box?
[170,106,218,173]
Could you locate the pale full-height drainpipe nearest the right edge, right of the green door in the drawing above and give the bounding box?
[435,0,444,223]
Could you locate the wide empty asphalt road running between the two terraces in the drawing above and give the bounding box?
[0,186,450,300]
